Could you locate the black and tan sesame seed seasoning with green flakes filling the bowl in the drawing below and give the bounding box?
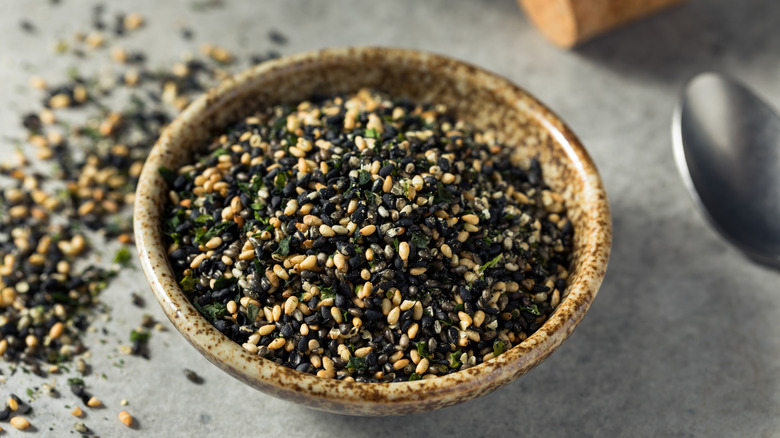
[160,90,572,382]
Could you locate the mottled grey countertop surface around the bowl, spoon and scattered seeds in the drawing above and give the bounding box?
[0,0,780,438]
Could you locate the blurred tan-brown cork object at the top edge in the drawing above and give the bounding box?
[518,0,683,48]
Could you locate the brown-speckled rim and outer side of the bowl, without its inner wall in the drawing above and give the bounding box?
[133,47,612,415]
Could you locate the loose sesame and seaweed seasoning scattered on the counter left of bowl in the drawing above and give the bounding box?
[0,1,288,433]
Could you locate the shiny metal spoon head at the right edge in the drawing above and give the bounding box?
[672,73,780,268]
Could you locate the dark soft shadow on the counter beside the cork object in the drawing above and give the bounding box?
[574,0,780,82]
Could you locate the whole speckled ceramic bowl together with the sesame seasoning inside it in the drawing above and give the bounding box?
[134,48,611,415]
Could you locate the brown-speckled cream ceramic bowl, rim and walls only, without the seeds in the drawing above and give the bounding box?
[134,48,612,416]
